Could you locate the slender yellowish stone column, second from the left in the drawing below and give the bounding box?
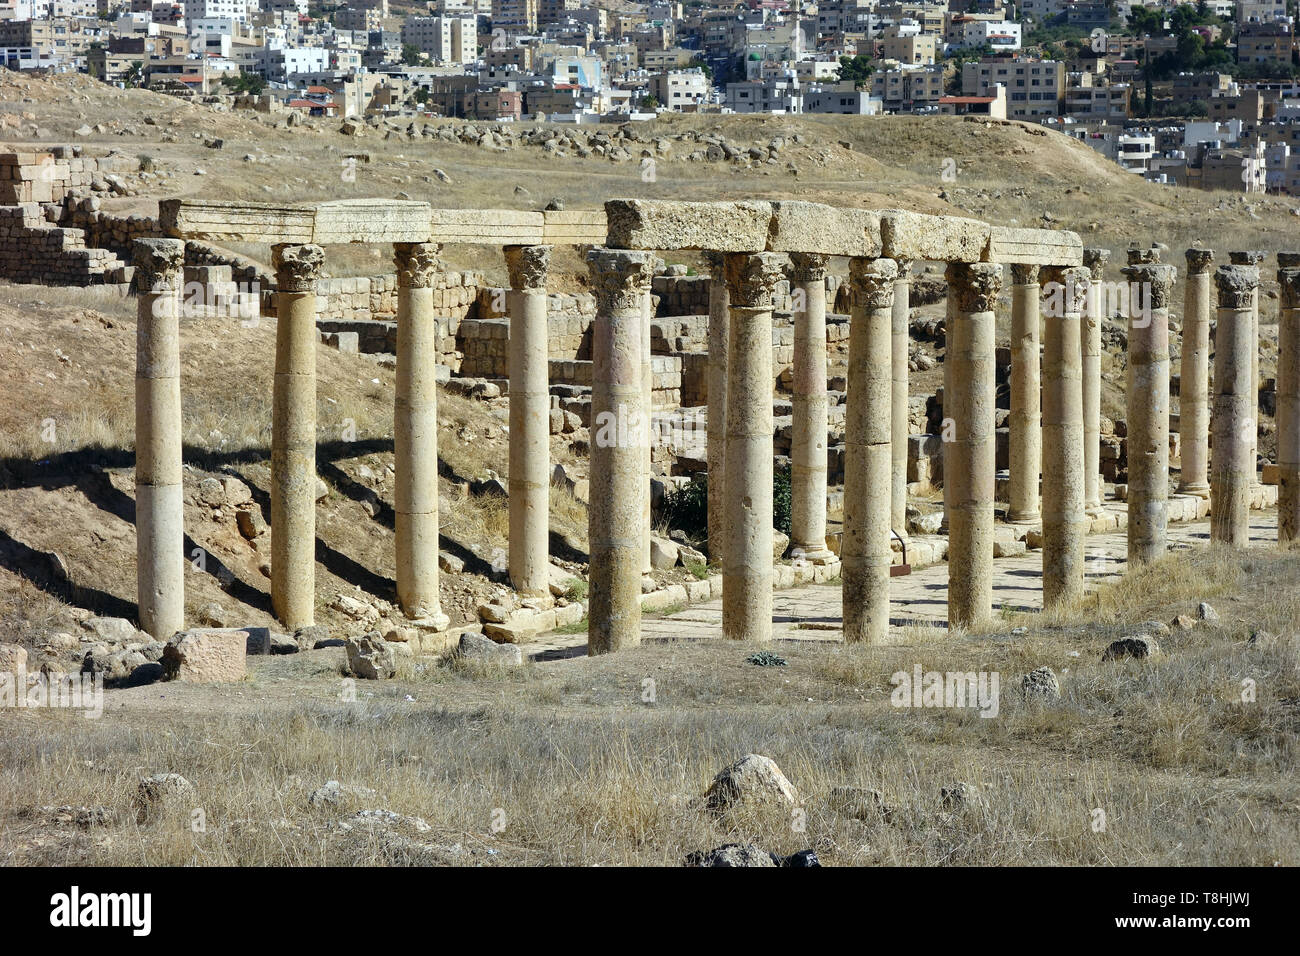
[270,245,325,630]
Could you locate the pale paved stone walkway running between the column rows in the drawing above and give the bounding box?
[524,509,1278,659]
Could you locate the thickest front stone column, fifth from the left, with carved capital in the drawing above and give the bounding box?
[586,248,654,654]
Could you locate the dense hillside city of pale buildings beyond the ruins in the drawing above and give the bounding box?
[0,0,1300,195]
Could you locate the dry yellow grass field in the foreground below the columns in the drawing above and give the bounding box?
[0,553,1300,865]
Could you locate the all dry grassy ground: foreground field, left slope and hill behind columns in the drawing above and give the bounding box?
[0,73,1300,866]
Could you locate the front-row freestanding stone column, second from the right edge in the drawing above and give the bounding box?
[1210,265,1260,548]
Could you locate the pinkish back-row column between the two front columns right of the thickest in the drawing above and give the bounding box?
[790,252,833,564]
